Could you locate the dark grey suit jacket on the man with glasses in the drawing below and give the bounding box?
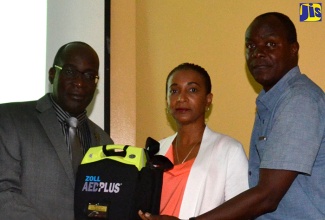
[0,95,113,220]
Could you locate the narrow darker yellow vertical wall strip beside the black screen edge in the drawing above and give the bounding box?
[110,0,138,145]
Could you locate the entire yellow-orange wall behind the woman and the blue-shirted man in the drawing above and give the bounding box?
[111,0,325,155]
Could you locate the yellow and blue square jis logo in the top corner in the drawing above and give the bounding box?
[299,3,322,22]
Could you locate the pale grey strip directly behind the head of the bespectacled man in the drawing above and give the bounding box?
[46,0,104,128]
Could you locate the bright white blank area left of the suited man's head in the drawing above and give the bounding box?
[0,0,47,103]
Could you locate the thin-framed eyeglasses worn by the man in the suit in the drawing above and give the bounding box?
[54,65,99,84]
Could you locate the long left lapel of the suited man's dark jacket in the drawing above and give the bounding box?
[36,95,75,187]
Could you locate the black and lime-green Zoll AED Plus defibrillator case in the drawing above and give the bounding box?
[74,137,173,220]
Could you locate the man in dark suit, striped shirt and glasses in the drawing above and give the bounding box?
[0,42,113,220]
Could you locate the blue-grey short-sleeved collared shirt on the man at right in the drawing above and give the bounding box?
[249,67,325,220]
